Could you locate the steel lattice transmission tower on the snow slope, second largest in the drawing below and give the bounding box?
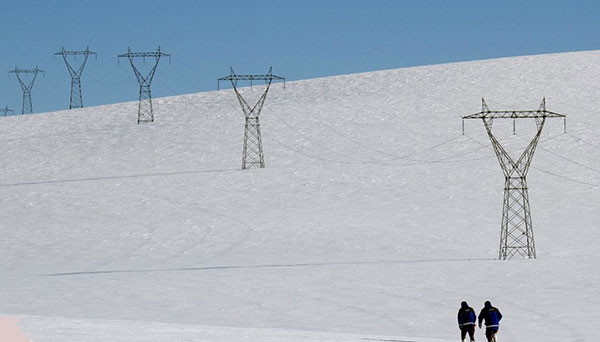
[217,67,285,170]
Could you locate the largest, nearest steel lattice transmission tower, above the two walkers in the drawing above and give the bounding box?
[462,98,566,260]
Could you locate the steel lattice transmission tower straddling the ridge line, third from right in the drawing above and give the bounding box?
[119,46,171,124]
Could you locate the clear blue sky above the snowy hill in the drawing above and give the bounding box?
[0,0,600,113]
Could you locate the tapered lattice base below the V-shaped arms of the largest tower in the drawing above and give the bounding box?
[499,177,536,260]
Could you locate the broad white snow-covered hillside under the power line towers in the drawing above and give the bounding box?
[0,51,600,342]
